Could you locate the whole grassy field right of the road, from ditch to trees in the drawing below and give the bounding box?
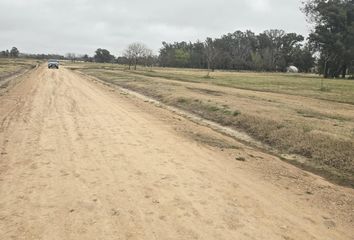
[68,63,354,186]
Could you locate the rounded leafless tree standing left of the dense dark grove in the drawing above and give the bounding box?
[124,43,152,70]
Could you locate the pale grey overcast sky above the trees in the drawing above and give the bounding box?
[0,0,308,55]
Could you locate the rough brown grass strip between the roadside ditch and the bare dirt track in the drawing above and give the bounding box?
[74,65,354,186]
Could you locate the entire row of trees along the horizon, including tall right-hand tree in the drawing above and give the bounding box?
[0,0,354,78]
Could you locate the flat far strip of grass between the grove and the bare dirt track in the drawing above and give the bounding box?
[66,64,354,104]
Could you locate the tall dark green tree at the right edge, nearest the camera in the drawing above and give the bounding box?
[303,0,354,78]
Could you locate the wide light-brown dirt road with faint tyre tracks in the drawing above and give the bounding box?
[0,66,354,240]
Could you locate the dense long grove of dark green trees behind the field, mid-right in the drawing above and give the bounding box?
[159,30,314,72]
